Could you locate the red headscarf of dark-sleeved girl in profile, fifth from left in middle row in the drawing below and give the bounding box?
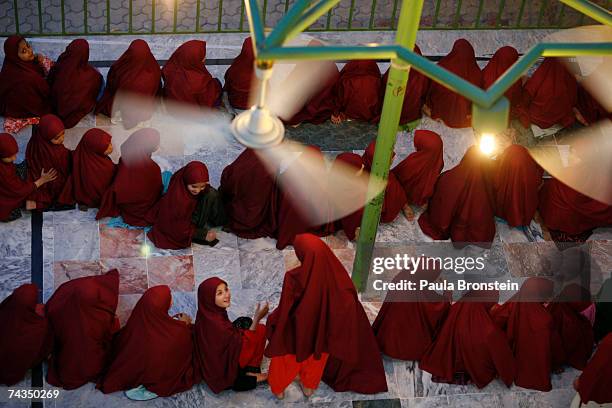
[147,161,208,249]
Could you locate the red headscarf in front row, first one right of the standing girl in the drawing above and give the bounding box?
[372,269,450,361]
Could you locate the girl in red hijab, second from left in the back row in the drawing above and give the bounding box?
[48,38,102,129]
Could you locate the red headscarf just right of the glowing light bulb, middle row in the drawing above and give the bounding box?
[493,144,544,227]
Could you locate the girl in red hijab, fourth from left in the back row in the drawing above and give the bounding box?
[162,40,222,108]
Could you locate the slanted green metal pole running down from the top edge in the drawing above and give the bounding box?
[352,0,423,292]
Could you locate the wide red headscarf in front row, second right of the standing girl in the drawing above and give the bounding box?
[419,291,515,388]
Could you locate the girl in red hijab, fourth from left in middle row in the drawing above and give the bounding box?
[96,128,164,227]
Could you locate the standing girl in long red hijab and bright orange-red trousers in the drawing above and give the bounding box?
[266,234,387,398]
